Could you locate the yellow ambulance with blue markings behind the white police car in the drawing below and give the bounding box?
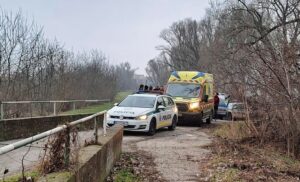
[165,71,214,126]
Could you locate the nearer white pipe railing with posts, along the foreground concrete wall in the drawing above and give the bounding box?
[0,110,107,166]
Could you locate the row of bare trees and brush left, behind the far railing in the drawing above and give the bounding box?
[0,10,136,116]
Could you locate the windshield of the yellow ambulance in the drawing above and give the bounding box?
[167,83,200,98]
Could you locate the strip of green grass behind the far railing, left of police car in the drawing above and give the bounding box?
[61,91,132,114]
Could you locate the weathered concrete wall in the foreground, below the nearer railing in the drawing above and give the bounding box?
[37,126,123,182]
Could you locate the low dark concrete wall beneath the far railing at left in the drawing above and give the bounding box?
[0,114,103,141]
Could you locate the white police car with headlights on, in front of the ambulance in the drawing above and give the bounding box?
[107,94,178,135]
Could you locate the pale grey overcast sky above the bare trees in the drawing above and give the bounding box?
[0,0,209,74]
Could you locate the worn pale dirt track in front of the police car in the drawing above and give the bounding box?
[123,127,211,182]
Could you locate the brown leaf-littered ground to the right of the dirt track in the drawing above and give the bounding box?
[201,122,300,182]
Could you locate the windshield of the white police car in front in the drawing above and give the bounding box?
[118,96,155,108]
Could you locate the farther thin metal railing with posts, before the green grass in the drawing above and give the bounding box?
[0,99,110,120]
